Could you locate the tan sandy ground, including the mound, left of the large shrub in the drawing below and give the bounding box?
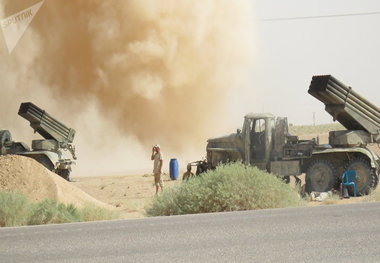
[0,155,181,218]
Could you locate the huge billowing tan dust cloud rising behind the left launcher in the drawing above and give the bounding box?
[0,0,254,175]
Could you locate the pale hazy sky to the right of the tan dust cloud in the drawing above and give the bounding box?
[229,0,380,128]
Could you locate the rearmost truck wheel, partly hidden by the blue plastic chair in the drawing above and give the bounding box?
[347,158,377,195]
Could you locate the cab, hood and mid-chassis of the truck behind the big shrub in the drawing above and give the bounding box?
[207,113,319,185]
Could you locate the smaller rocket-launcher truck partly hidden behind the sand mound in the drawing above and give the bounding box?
[0,102,76,180]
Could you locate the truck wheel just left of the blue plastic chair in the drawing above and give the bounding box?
[306,159,337,193]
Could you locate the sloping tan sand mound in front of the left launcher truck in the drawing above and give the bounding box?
[0,155,112,208]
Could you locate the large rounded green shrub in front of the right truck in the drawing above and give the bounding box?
[146,163,303,216]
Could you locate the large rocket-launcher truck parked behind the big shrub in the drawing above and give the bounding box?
[197,75,380,195]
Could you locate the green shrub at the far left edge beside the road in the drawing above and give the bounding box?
[0,192,30,227]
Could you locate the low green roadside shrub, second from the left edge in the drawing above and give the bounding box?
[28,199,80,225]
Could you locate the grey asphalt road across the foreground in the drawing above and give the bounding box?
[0,203,380,263]
